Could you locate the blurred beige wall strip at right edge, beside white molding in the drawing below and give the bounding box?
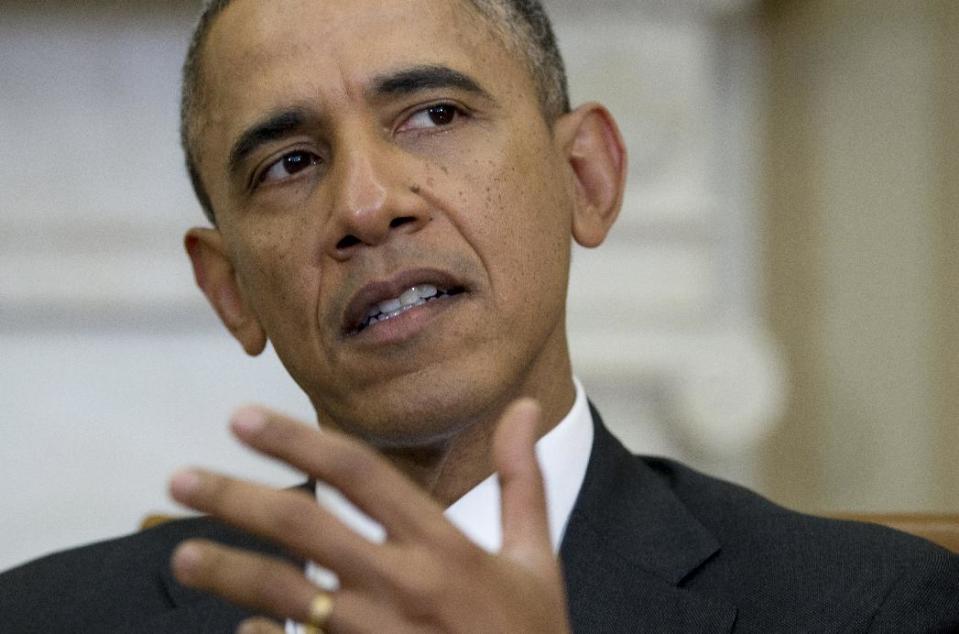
[761,0,959,510]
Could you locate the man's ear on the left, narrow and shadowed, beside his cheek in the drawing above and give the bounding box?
[183,228,266,356]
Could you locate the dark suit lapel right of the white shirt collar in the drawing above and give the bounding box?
[560,406,736,633]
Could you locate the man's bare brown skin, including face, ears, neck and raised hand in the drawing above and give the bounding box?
[178,0,625,632]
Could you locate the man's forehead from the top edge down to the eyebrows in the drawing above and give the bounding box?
[193,0,538,174]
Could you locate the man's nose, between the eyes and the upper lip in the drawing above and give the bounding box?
[328,130,429,260]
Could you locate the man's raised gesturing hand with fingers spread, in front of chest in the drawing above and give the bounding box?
[170,400,569,634]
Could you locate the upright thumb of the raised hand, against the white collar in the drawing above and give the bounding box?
[493,399,555,568]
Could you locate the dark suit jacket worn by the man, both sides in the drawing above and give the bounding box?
[0,412,959,634]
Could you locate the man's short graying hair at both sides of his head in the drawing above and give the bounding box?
[180,0,570,224]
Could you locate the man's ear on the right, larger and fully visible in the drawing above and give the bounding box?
[555,103,626,248]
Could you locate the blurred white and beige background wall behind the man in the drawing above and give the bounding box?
[0,0,959,569]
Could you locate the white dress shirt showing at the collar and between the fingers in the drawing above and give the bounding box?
[286,377,593,634]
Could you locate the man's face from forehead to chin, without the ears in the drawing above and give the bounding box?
[198,0,575,445]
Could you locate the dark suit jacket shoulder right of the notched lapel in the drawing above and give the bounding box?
[637,458,959,631]
